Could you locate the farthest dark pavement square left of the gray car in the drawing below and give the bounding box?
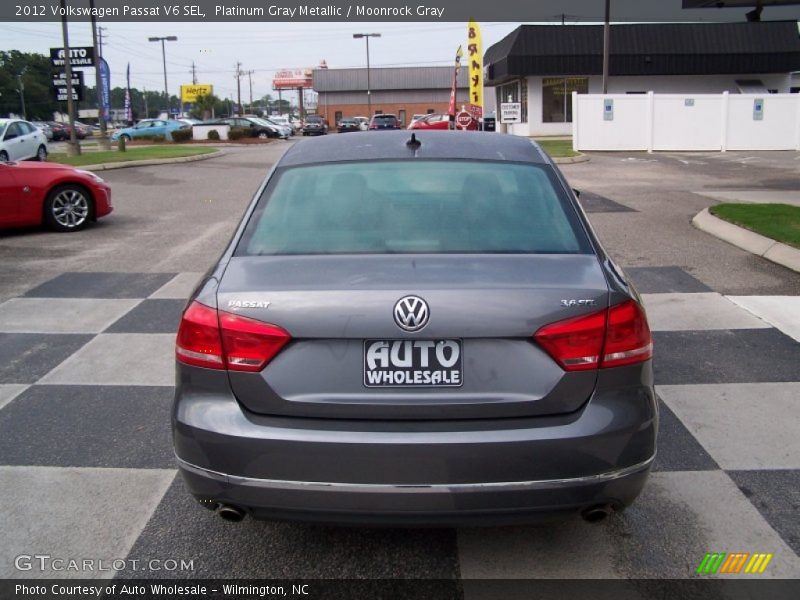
[25,273,176,298]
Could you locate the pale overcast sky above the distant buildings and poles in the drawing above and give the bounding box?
[0,22,519,101]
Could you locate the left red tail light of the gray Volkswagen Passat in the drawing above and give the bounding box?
[175,302,292,372]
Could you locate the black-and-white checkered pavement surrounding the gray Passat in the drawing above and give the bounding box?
[0,267,800,579]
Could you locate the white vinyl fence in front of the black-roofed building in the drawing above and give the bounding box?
[572,92,800,152]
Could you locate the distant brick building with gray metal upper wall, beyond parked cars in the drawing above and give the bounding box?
[313,67,469,126]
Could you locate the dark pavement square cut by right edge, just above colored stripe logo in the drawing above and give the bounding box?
[727,469,800,554]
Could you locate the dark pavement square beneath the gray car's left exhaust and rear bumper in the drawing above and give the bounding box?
[117,476,459,579]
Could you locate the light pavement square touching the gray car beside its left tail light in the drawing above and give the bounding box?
[38,333,175,386]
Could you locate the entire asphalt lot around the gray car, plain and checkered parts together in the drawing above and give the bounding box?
[0,142,800,589]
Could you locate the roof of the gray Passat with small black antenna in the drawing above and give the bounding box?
[278,130,549,167]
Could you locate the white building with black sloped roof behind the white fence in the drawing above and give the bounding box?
[484,21,800,135]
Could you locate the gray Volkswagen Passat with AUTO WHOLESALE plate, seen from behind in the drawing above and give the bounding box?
[173,131,658,525]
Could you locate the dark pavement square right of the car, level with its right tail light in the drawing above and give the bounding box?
[653,329,800,385]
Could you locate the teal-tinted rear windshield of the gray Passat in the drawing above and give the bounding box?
[236,160,591,256]
